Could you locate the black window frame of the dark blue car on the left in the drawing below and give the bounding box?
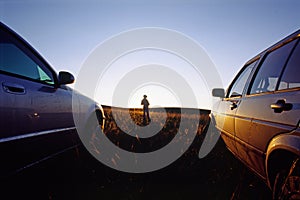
[0,24,58,88]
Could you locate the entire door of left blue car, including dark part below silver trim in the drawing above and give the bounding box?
[0,22,79,174]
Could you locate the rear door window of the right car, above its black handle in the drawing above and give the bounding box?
[250,40,296,94]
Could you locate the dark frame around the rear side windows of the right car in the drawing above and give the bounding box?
[246,35,300,97]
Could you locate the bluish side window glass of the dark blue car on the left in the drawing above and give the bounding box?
[0,28,54,85]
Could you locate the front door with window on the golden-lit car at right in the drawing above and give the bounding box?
[216,61,257,157]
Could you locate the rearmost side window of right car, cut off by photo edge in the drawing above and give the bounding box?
[278,39,300,90]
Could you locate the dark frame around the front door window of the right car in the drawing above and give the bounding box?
[224,55,260,100]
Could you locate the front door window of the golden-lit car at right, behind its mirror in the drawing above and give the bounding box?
[227,61,257,98]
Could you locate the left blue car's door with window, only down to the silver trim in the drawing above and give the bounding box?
[0,25,74,135]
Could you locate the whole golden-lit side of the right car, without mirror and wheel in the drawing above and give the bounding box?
[212,30,300,187]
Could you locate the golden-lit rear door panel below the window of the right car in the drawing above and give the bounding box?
[235,91,300,176]
